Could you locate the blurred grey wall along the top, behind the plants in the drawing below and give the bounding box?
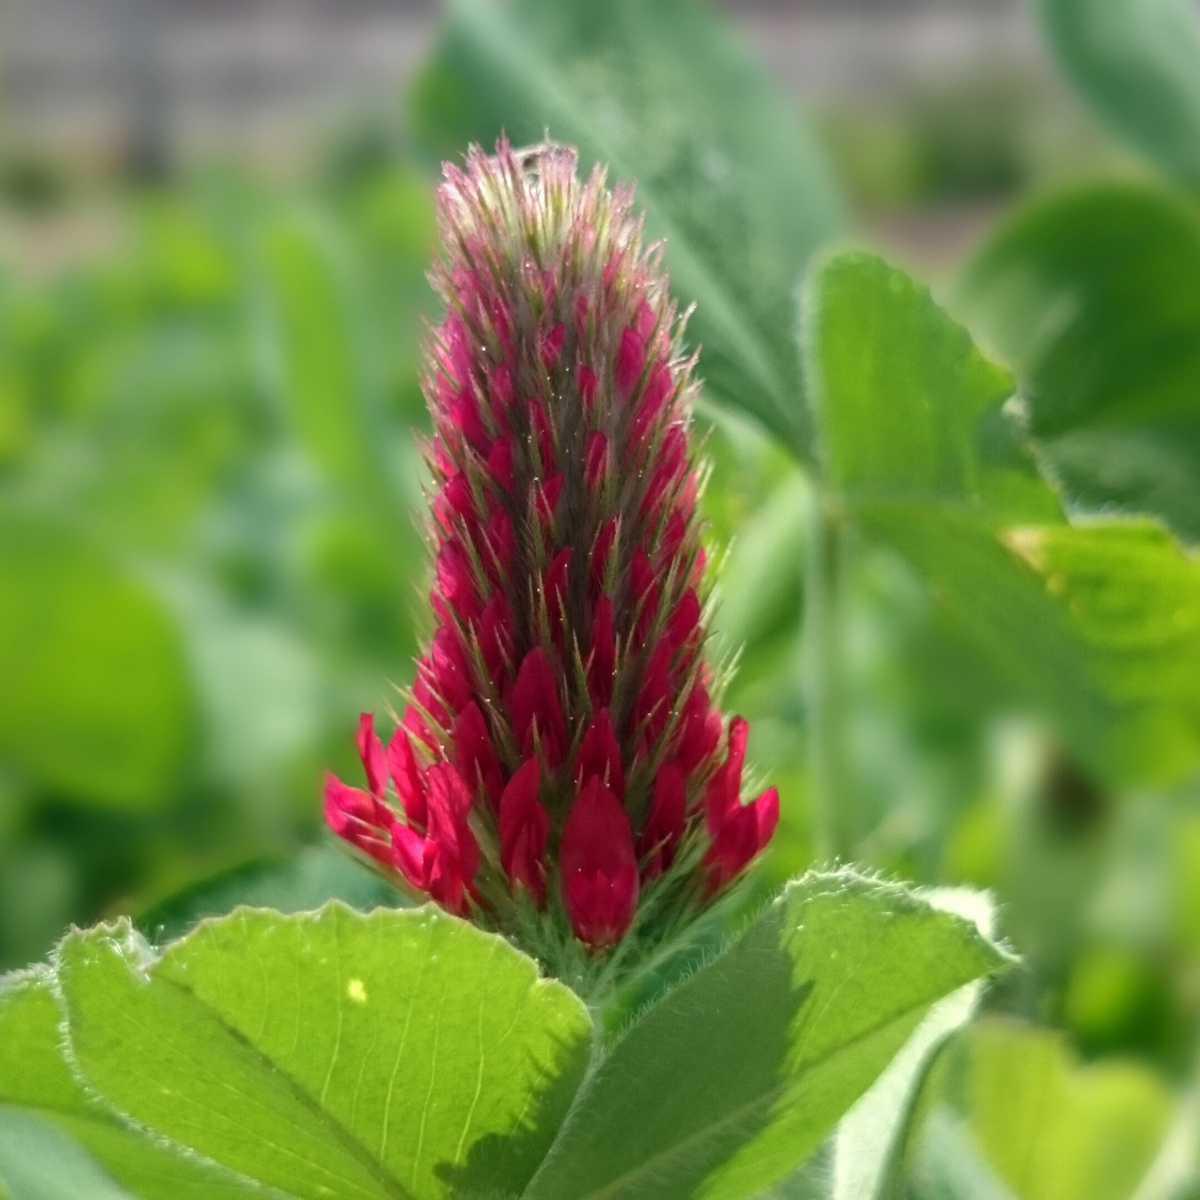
[0,0,1039,160]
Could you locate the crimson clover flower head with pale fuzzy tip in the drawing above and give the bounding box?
[325,142,779,979]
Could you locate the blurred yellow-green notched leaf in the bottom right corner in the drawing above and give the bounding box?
[970,1021,1171,1200]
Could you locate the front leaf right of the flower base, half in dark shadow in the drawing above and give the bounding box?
[528,870,1006,1200]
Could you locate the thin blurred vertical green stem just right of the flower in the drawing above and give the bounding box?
[805,493,859,859]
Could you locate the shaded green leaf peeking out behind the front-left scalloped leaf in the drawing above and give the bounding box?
[136,846,407,944]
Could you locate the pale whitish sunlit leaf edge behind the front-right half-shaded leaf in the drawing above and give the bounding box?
[832,888,996,1200]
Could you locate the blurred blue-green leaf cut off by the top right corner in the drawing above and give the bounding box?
[1042,0,1200,186]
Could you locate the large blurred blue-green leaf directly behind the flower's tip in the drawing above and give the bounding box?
[414,0,840,450]
